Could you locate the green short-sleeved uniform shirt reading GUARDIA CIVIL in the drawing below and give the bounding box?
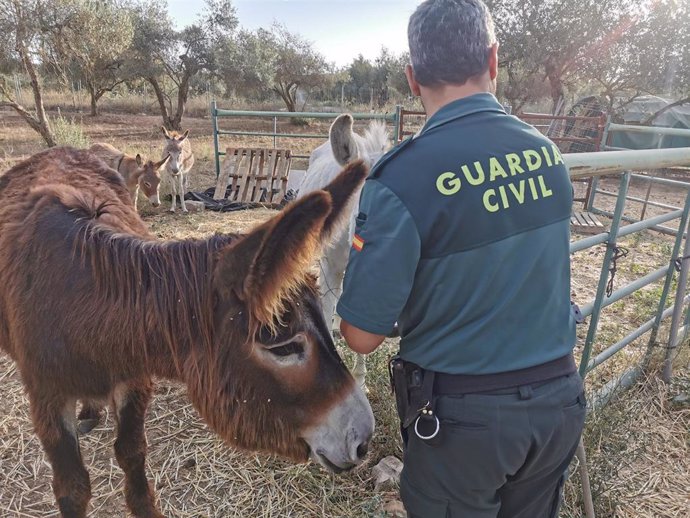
[338,93,575,374]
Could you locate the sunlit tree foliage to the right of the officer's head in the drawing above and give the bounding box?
[487,0,690,110]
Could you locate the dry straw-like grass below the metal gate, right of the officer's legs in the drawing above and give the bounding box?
[562,362,690,518]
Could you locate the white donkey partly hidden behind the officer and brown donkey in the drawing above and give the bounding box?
[297,113,390,387]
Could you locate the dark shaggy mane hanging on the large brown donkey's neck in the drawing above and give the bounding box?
[68,195,238,371]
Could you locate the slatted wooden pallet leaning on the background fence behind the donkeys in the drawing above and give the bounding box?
[213,148,292,204]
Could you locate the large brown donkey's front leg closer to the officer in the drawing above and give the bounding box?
[114,380,163,518]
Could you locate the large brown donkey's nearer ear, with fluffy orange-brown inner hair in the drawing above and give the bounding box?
[214,191,332,327]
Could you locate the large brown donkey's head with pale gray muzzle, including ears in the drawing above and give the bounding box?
[187,161,374,471]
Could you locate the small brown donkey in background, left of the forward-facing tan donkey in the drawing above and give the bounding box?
[89,142,170,209]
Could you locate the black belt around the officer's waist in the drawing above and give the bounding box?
[434,354,577,396]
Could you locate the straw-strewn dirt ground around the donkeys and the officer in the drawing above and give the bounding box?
[0,107,690,518]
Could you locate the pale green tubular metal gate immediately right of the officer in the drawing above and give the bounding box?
[564,148,690,518]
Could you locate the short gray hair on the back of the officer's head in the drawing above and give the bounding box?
[407,0,496,86]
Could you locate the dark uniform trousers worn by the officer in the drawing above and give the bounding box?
[400,373,586,518]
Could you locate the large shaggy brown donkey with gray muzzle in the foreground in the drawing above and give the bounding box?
[0,148,374,518]
